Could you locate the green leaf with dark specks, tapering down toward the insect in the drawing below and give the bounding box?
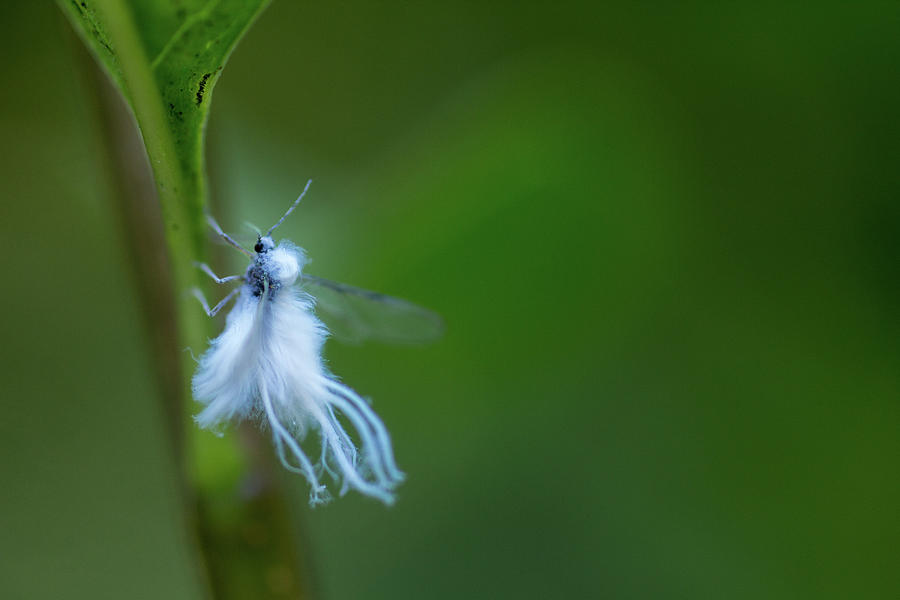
[59,0,269,308]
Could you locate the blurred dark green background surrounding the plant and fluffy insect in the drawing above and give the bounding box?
[0,1,900,600]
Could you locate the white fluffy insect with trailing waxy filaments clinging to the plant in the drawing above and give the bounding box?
[192,182,442,505]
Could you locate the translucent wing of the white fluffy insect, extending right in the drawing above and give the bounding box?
[300,273,444,344]
